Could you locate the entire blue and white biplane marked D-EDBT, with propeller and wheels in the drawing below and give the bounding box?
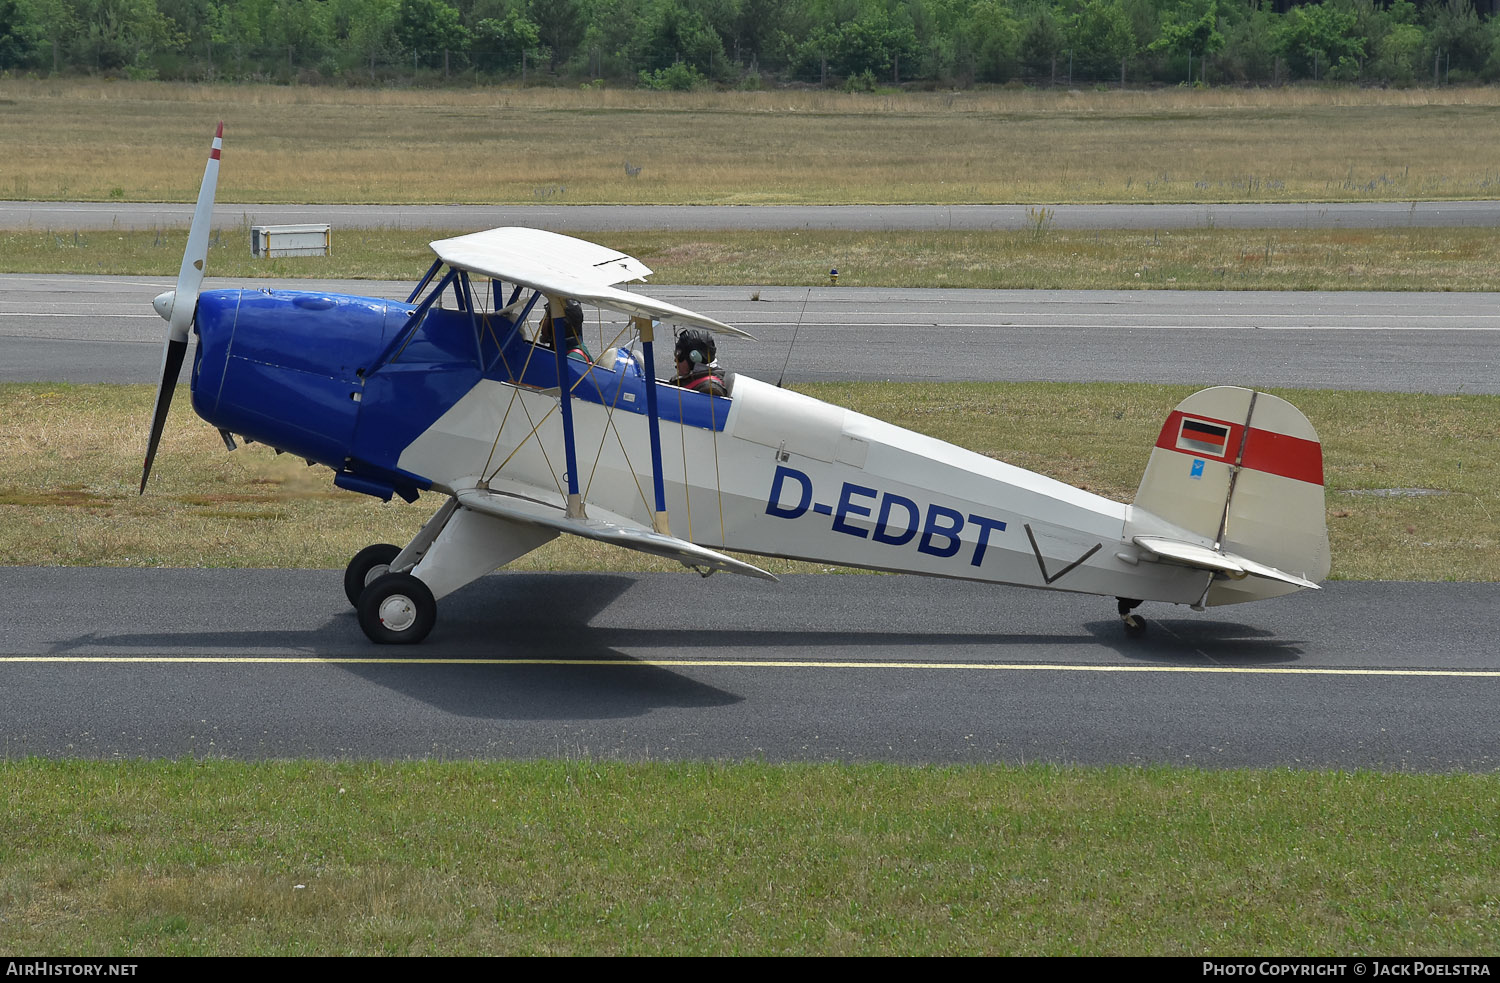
[141,123,1329,642]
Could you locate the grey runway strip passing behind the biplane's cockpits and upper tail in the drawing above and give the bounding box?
[0,275,1500,393]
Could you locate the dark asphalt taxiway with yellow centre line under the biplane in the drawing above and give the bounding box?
[0,569,1500,771]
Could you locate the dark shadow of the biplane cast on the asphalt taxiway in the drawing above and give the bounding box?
[53,573,1301,720]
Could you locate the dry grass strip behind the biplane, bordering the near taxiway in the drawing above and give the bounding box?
[0,383,1500,581]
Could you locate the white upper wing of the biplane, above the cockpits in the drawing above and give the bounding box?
[432,228,755,338]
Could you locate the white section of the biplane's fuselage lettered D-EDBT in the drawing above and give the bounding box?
[399,375,1209,603]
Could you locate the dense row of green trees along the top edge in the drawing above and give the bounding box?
[0,0,1500,90]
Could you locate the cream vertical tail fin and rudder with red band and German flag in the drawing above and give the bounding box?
[1125,386,1329,605]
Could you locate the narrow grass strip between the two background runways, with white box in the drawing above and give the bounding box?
[0,226,1500,290]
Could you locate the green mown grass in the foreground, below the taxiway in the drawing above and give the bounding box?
[0,761,1500,956]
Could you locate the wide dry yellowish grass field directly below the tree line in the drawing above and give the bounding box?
[0,80,1500,204]
